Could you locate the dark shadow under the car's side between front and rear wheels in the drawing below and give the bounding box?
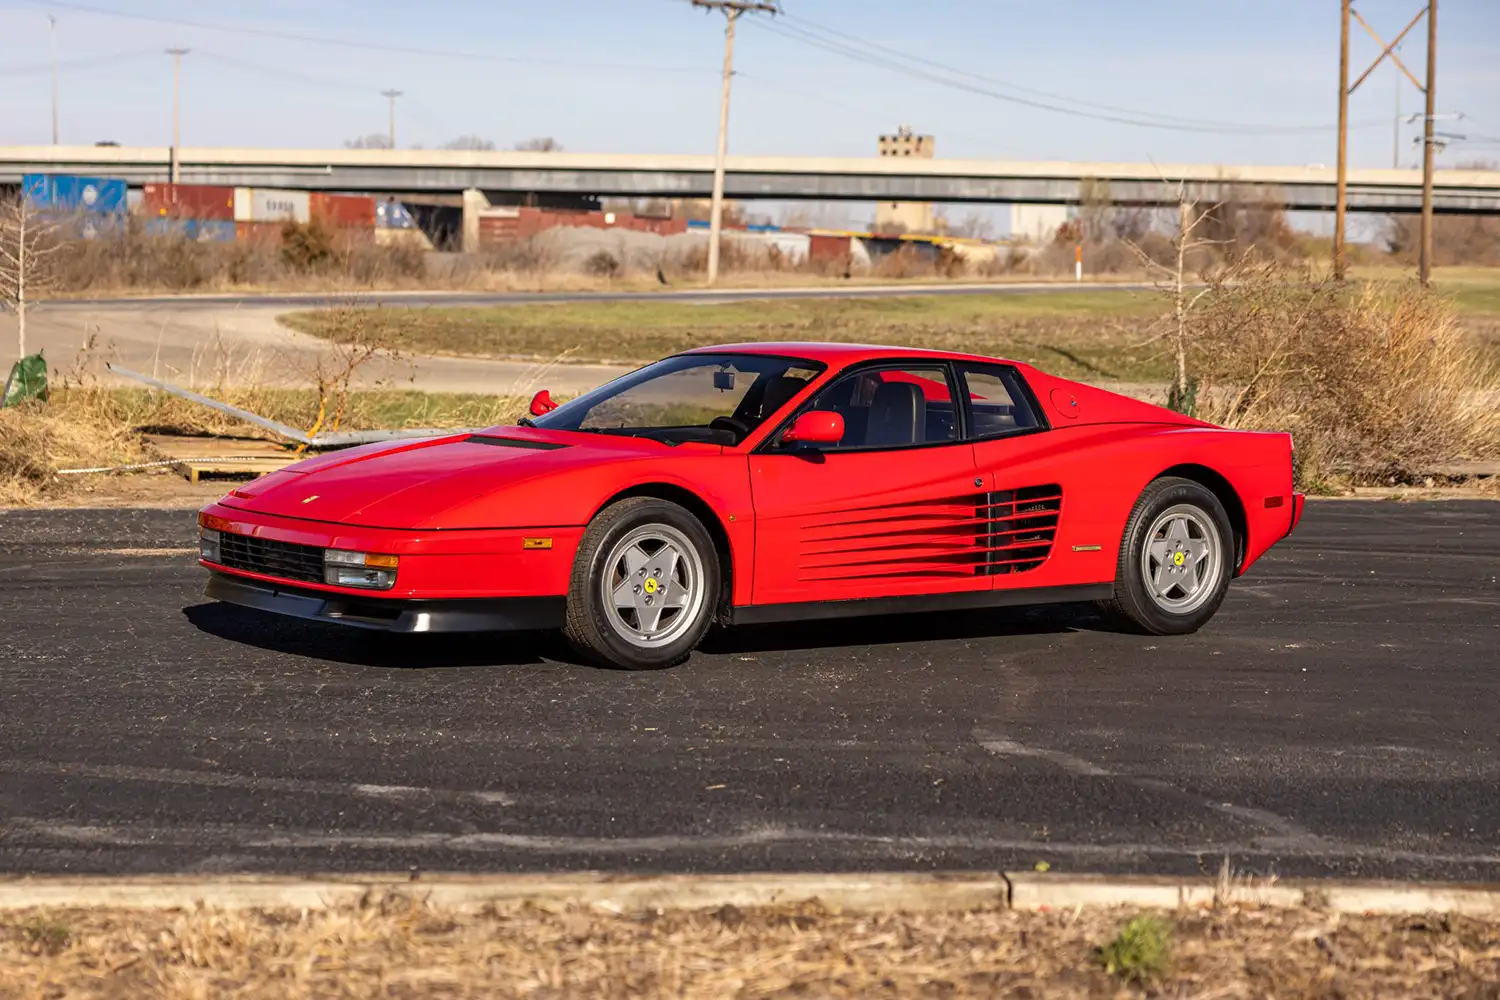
[699,604,1109,654]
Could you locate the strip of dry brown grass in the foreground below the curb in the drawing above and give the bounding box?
[0,897,1500,1000]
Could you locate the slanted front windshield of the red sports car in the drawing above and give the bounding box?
[531,354,824,445]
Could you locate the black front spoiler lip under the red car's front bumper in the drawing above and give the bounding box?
[204,573,567,633]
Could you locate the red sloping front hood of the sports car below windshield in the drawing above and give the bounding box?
[221,427,690,529]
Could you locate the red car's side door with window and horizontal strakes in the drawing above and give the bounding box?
[750,363,992,604]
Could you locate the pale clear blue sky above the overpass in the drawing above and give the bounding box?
[0,0,1500,166]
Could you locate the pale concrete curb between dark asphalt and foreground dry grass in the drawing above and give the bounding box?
[0,873,1500,918]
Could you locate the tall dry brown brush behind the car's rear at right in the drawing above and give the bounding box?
[1190,265,1500,486]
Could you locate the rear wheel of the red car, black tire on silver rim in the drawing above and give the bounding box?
[1100,477,1239,636]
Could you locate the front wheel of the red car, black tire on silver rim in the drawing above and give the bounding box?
[563,496,720,670]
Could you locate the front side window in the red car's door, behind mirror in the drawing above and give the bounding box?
[804,366,959,451]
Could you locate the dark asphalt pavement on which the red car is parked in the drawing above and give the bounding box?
[0,501,1500,880]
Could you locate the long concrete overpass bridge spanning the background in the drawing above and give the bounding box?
[0,145,1500,214]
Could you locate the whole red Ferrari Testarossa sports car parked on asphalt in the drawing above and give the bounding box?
[198,343,1302,669]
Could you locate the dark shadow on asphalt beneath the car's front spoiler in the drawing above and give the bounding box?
[183,603,572,670]
